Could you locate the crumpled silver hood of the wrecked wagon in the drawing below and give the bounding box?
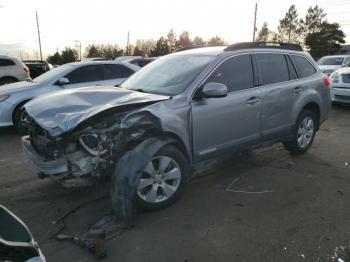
[25,87,169,137]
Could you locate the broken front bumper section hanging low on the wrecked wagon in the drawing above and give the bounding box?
[22,136,68,176]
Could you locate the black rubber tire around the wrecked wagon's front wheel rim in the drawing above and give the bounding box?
[135,145,190,211]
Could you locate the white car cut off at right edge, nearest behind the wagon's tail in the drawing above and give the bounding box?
[330,67,350,104]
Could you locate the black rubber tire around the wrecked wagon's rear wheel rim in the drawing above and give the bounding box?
[283,110,318,155]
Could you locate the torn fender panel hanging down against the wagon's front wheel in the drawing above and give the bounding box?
[111,138,174,226]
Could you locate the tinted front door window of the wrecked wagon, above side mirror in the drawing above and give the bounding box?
[206,54,254,92]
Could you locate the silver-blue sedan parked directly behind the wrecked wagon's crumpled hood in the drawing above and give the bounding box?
[0,61,140,128]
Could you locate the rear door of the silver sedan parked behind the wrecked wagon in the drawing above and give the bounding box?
[103,64,134,86]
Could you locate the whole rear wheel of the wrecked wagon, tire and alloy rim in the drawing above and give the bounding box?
[283,110,317,154]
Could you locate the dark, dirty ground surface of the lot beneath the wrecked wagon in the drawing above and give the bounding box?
[0,106,350,262]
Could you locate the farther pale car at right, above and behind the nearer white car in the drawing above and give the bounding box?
[317,55,350,76]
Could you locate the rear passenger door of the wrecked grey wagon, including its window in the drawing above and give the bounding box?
[254,53,302,139]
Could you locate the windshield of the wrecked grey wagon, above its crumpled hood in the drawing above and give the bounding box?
[122,55,215,96]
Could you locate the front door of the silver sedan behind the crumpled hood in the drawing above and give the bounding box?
[63,64,104,88]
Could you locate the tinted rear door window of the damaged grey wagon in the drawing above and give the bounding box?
[255,53,289,85]
